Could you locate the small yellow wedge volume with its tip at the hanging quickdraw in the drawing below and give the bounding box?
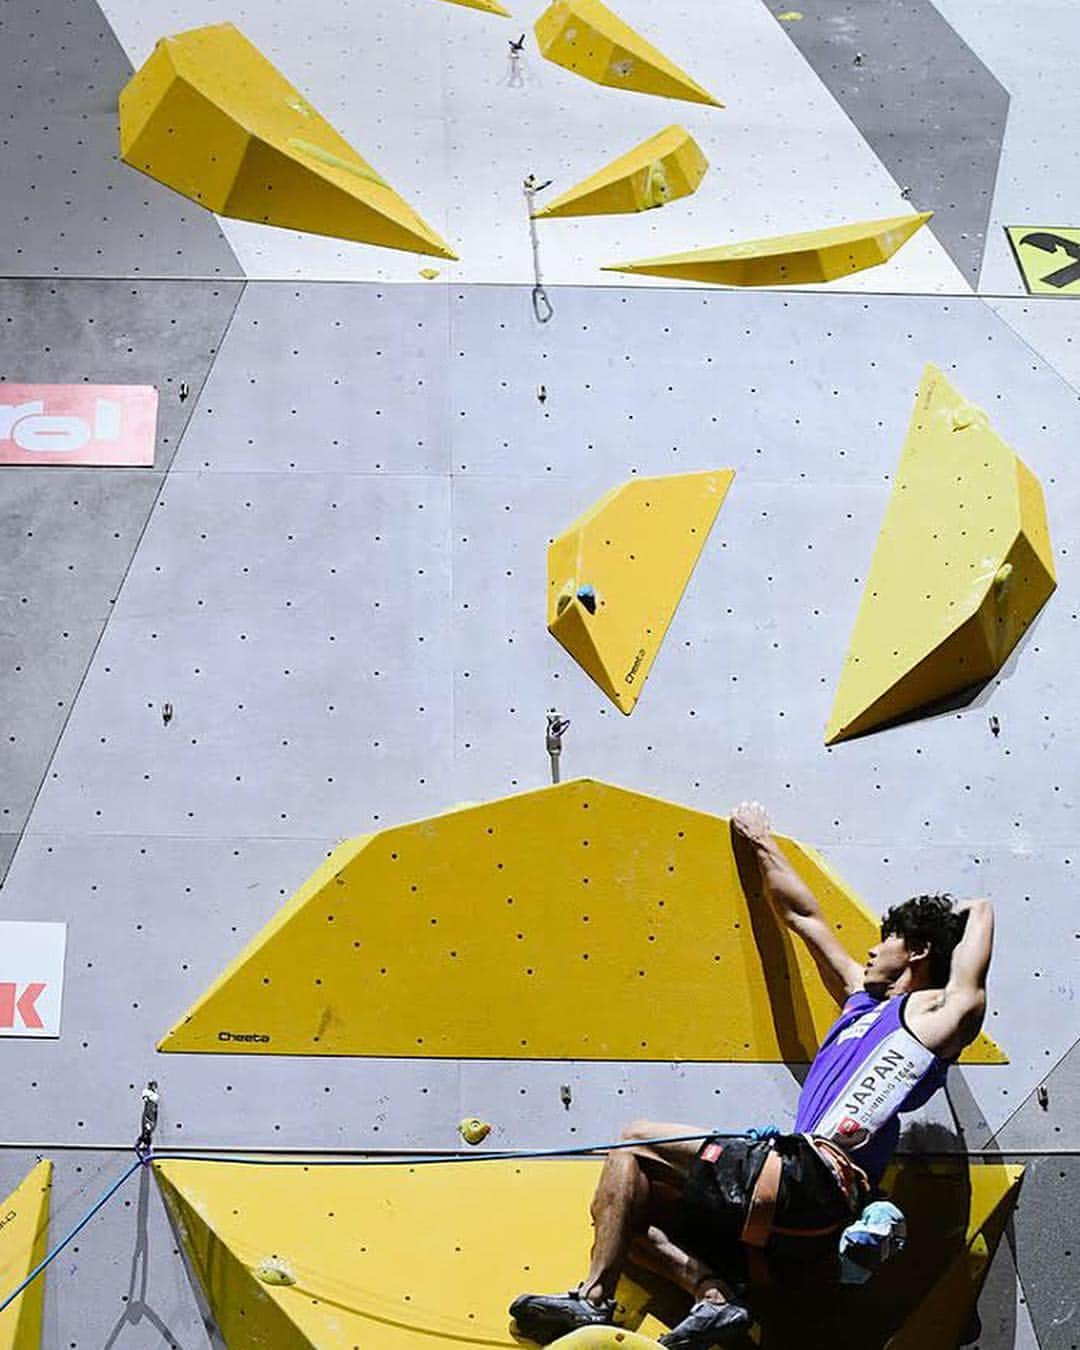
[535,127,709,217]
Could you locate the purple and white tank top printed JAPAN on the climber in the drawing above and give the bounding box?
[795,990,949,1181]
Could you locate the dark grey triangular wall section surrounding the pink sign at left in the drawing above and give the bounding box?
[0,279,243,880]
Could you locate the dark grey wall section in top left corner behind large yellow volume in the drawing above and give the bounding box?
[0,0,243,277]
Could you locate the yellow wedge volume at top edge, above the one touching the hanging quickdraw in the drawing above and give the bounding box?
[535,0,724,108]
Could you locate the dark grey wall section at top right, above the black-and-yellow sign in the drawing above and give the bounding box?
[768,0,1008,285]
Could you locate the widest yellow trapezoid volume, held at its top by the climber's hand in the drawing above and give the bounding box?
[159,779,1003,1062]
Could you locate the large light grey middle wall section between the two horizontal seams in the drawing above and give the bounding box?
[8,284,1080,1146]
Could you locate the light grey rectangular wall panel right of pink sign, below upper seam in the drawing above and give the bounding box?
[170,284,458,474]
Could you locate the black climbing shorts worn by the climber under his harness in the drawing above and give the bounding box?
[672,1134,855,1285]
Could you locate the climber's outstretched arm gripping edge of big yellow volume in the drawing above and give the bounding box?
[732,802,863,1004]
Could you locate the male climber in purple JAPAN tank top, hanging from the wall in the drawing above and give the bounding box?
[510,802,994,1350]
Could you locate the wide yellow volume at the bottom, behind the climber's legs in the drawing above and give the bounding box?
[154,1155,1017,1350]
